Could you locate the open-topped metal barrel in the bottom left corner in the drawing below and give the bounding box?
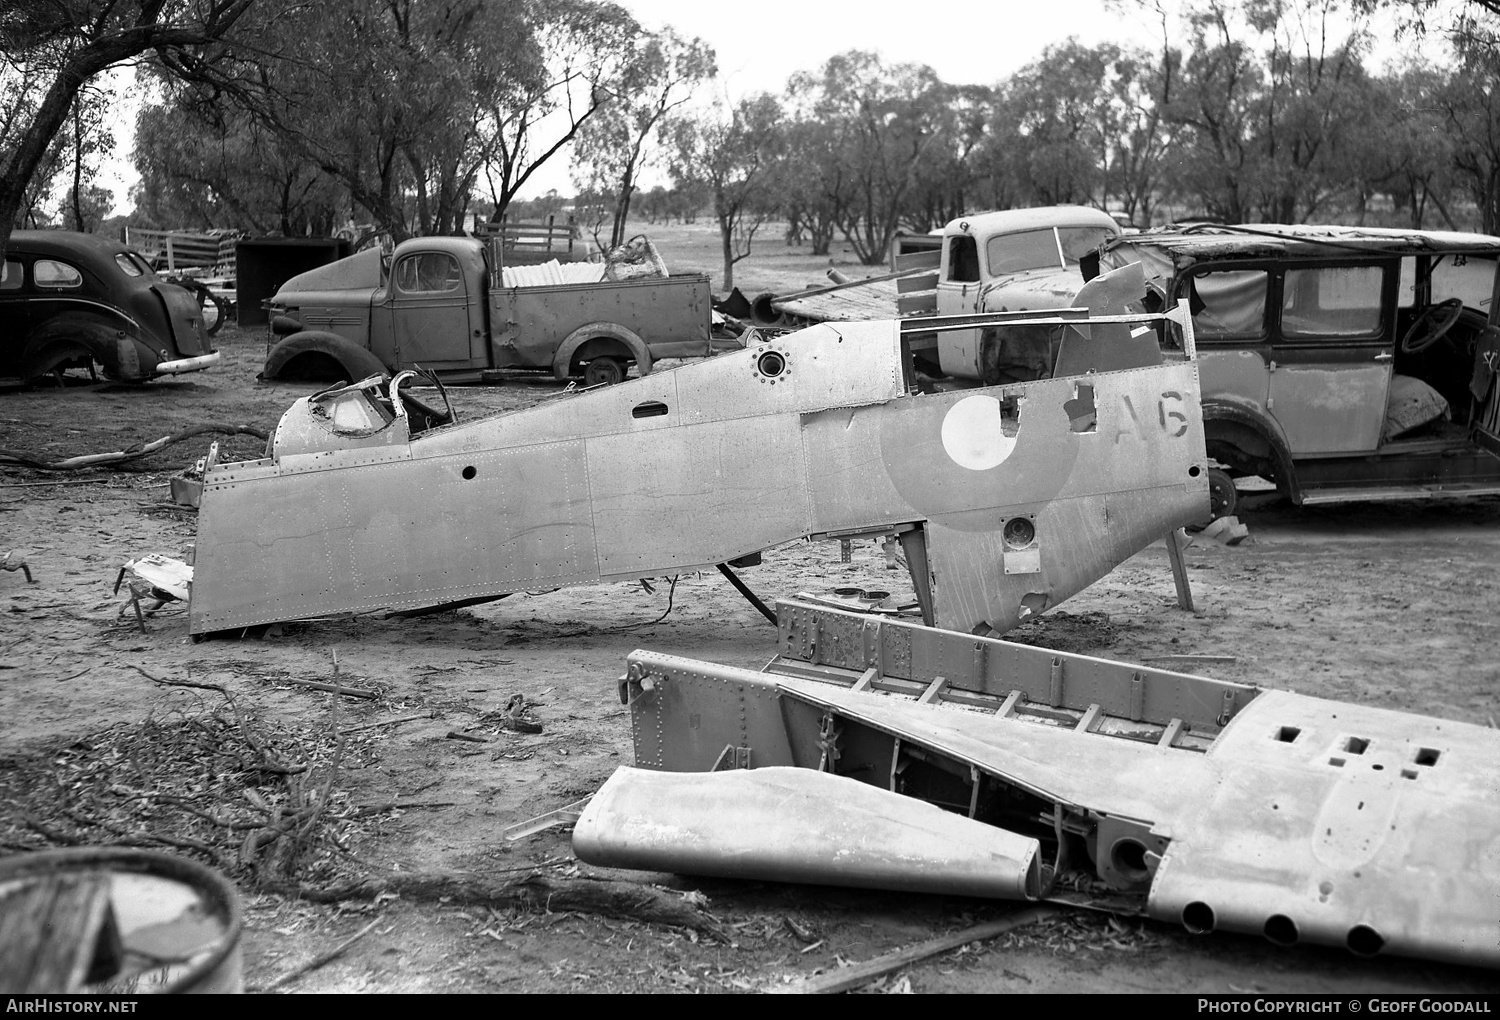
[0,846,245,995]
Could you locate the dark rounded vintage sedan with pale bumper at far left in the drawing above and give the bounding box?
[0,230,219,383]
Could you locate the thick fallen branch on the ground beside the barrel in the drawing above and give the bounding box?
[282,872,732,945]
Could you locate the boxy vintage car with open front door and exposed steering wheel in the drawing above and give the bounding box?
[1085,224,1500,516]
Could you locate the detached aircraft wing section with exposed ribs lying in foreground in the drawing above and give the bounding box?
[573,603,1500,968]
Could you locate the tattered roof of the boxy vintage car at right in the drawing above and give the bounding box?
[1104,224,1500,269]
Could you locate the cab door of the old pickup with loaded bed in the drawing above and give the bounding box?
[392,252,471,368]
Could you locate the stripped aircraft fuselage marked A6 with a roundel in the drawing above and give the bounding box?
[191,323,1208,635]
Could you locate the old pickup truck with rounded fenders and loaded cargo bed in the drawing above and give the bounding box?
[261,237,743,386]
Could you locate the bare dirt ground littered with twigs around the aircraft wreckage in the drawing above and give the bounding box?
[0,225,1500,995]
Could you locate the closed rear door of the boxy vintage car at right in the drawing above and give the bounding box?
[1266,263,1395,458]
